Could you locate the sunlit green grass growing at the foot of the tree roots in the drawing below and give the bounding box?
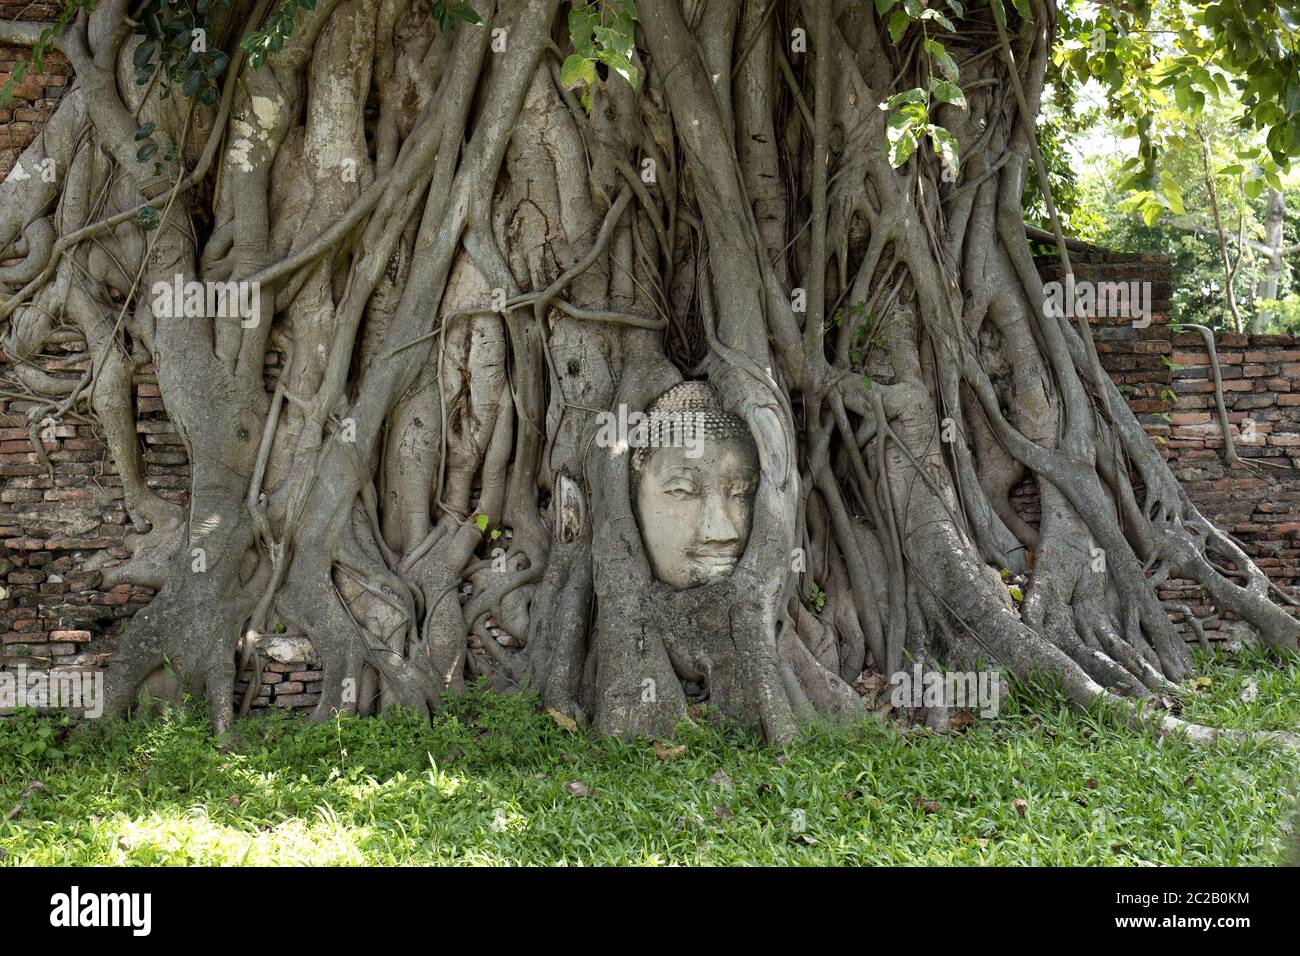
[0,652,1300,865]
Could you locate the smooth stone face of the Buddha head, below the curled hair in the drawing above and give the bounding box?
[636,436,759,588]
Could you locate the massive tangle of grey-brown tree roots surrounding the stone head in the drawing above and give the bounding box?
[0,0,1300,740]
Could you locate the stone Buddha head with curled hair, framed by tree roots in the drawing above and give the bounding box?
[632,381,759,588]
